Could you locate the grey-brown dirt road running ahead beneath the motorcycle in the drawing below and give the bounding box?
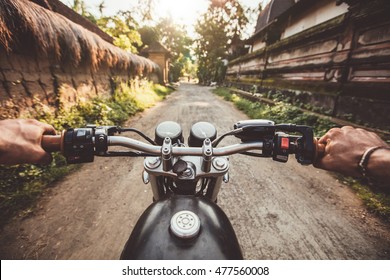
[0,84,390,259]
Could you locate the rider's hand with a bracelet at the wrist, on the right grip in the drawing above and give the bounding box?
[314,126,390,177]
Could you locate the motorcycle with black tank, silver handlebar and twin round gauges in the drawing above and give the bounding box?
[42,120,324,260]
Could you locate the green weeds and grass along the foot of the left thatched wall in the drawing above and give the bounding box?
[0,81,172,227]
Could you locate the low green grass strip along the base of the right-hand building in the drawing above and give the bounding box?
[214,87,390,222]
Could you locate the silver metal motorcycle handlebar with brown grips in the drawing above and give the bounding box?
[41,126,325,163]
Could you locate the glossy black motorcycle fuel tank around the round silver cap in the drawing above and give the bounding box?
[121,195,242,260]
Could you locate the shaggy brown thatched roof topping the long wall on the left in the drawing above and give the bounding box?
[0,0,158,74]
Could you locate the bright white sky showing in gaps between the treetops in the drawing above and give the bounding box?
[61,0,269,37]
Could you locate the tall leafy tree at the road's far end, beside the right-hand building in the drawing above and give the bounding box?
[195,0,248,83]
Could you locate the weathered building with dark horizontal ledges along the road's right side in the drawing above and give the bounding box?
[225,0,390,130]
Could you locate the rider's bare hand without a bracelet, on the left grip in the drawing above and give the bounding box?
[0,119,55,165]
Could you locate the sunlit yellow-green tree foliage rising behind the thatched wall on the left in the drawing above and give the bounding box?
[72,0,193,81]
